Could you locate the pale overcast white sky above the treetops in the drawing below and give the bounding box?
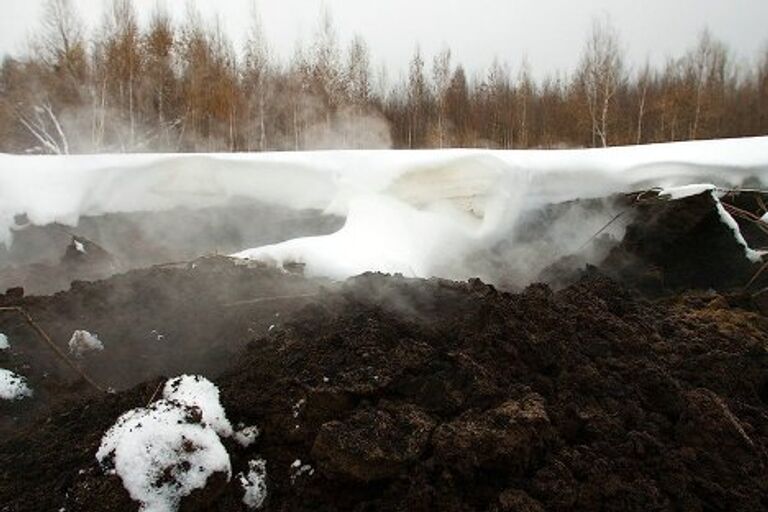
[0,0,768,78]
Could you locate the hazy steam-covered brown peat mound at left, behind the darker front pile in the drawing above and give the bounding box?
[0,257,328,432]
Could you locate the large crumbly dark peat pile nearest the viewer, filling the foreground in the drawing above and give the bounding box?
[0,275,768,511]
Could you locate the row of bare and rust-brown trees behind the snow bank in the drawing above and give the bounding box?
[0,0,768,154]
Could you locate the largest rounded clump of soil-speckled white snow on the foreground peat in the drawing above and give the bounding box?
[96,375,232,512]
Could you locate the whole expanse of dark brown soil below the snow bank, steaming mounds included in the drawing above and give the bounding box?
[0,193,768,512]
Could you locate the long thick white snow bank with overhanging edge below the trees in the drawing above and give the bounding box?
[0,137,768,280]
